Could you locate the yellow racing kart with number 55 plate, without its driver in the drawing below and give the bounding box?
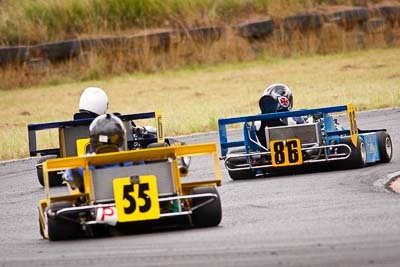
[38,143,222,241]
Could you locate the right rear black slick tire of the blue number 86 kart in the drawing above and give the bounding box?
[339,136,367,169]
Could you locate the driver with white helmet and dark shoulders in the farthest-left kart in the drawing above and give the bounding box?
[74,87,108,120]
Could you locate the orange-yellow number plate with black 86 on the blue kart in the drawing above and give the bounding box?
[269,139,303,167]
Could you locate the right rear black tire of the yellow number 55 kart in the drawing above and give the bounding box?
[192,186,222,227]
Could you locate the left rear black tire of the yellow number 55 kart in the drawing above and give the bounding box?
[47,201,81,241]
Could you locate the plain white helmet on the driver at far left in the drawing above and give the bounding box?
[79,87,108,115]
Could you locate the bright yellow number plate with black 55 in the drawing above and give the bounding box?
[113,175,160,222]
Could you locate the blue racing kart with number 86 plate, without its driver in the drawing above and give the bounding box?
[218,104,393,180]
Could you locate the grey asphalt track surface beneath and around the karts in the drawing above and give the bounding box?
[0,109,400,267]
